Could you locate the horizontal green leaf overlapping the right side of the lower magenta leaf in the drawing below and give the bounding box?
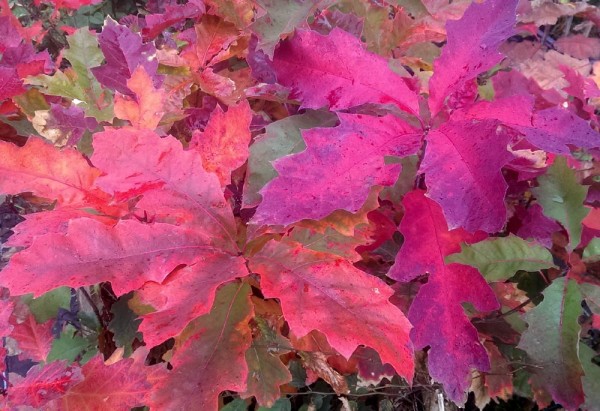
[446,235,554,281]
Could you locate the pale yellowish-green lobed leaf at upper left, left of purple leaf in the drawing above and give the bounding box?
[26,28,114,122]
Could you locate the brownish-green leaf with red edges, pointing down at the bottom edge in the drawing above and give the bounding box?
[149,283,253,411]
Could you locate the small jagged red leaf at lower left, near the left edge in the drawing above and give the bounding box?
[10,314,53,361]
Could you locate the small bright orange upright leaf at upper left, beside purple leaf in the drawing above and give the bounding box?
[115,66,165,130]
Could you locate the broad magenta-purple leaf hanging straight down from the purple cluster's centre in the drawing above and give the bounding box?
[420,121,511,233]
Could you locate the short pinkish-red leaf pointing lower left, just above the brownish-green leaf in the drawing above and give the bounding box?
[138,256,248,347]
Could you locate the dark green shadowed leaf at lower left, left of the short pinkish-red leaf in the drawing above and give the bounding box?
[108,292,142,357]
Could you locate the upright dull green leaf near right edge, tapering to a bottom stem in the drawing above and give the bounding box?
[532,157,590,250]
